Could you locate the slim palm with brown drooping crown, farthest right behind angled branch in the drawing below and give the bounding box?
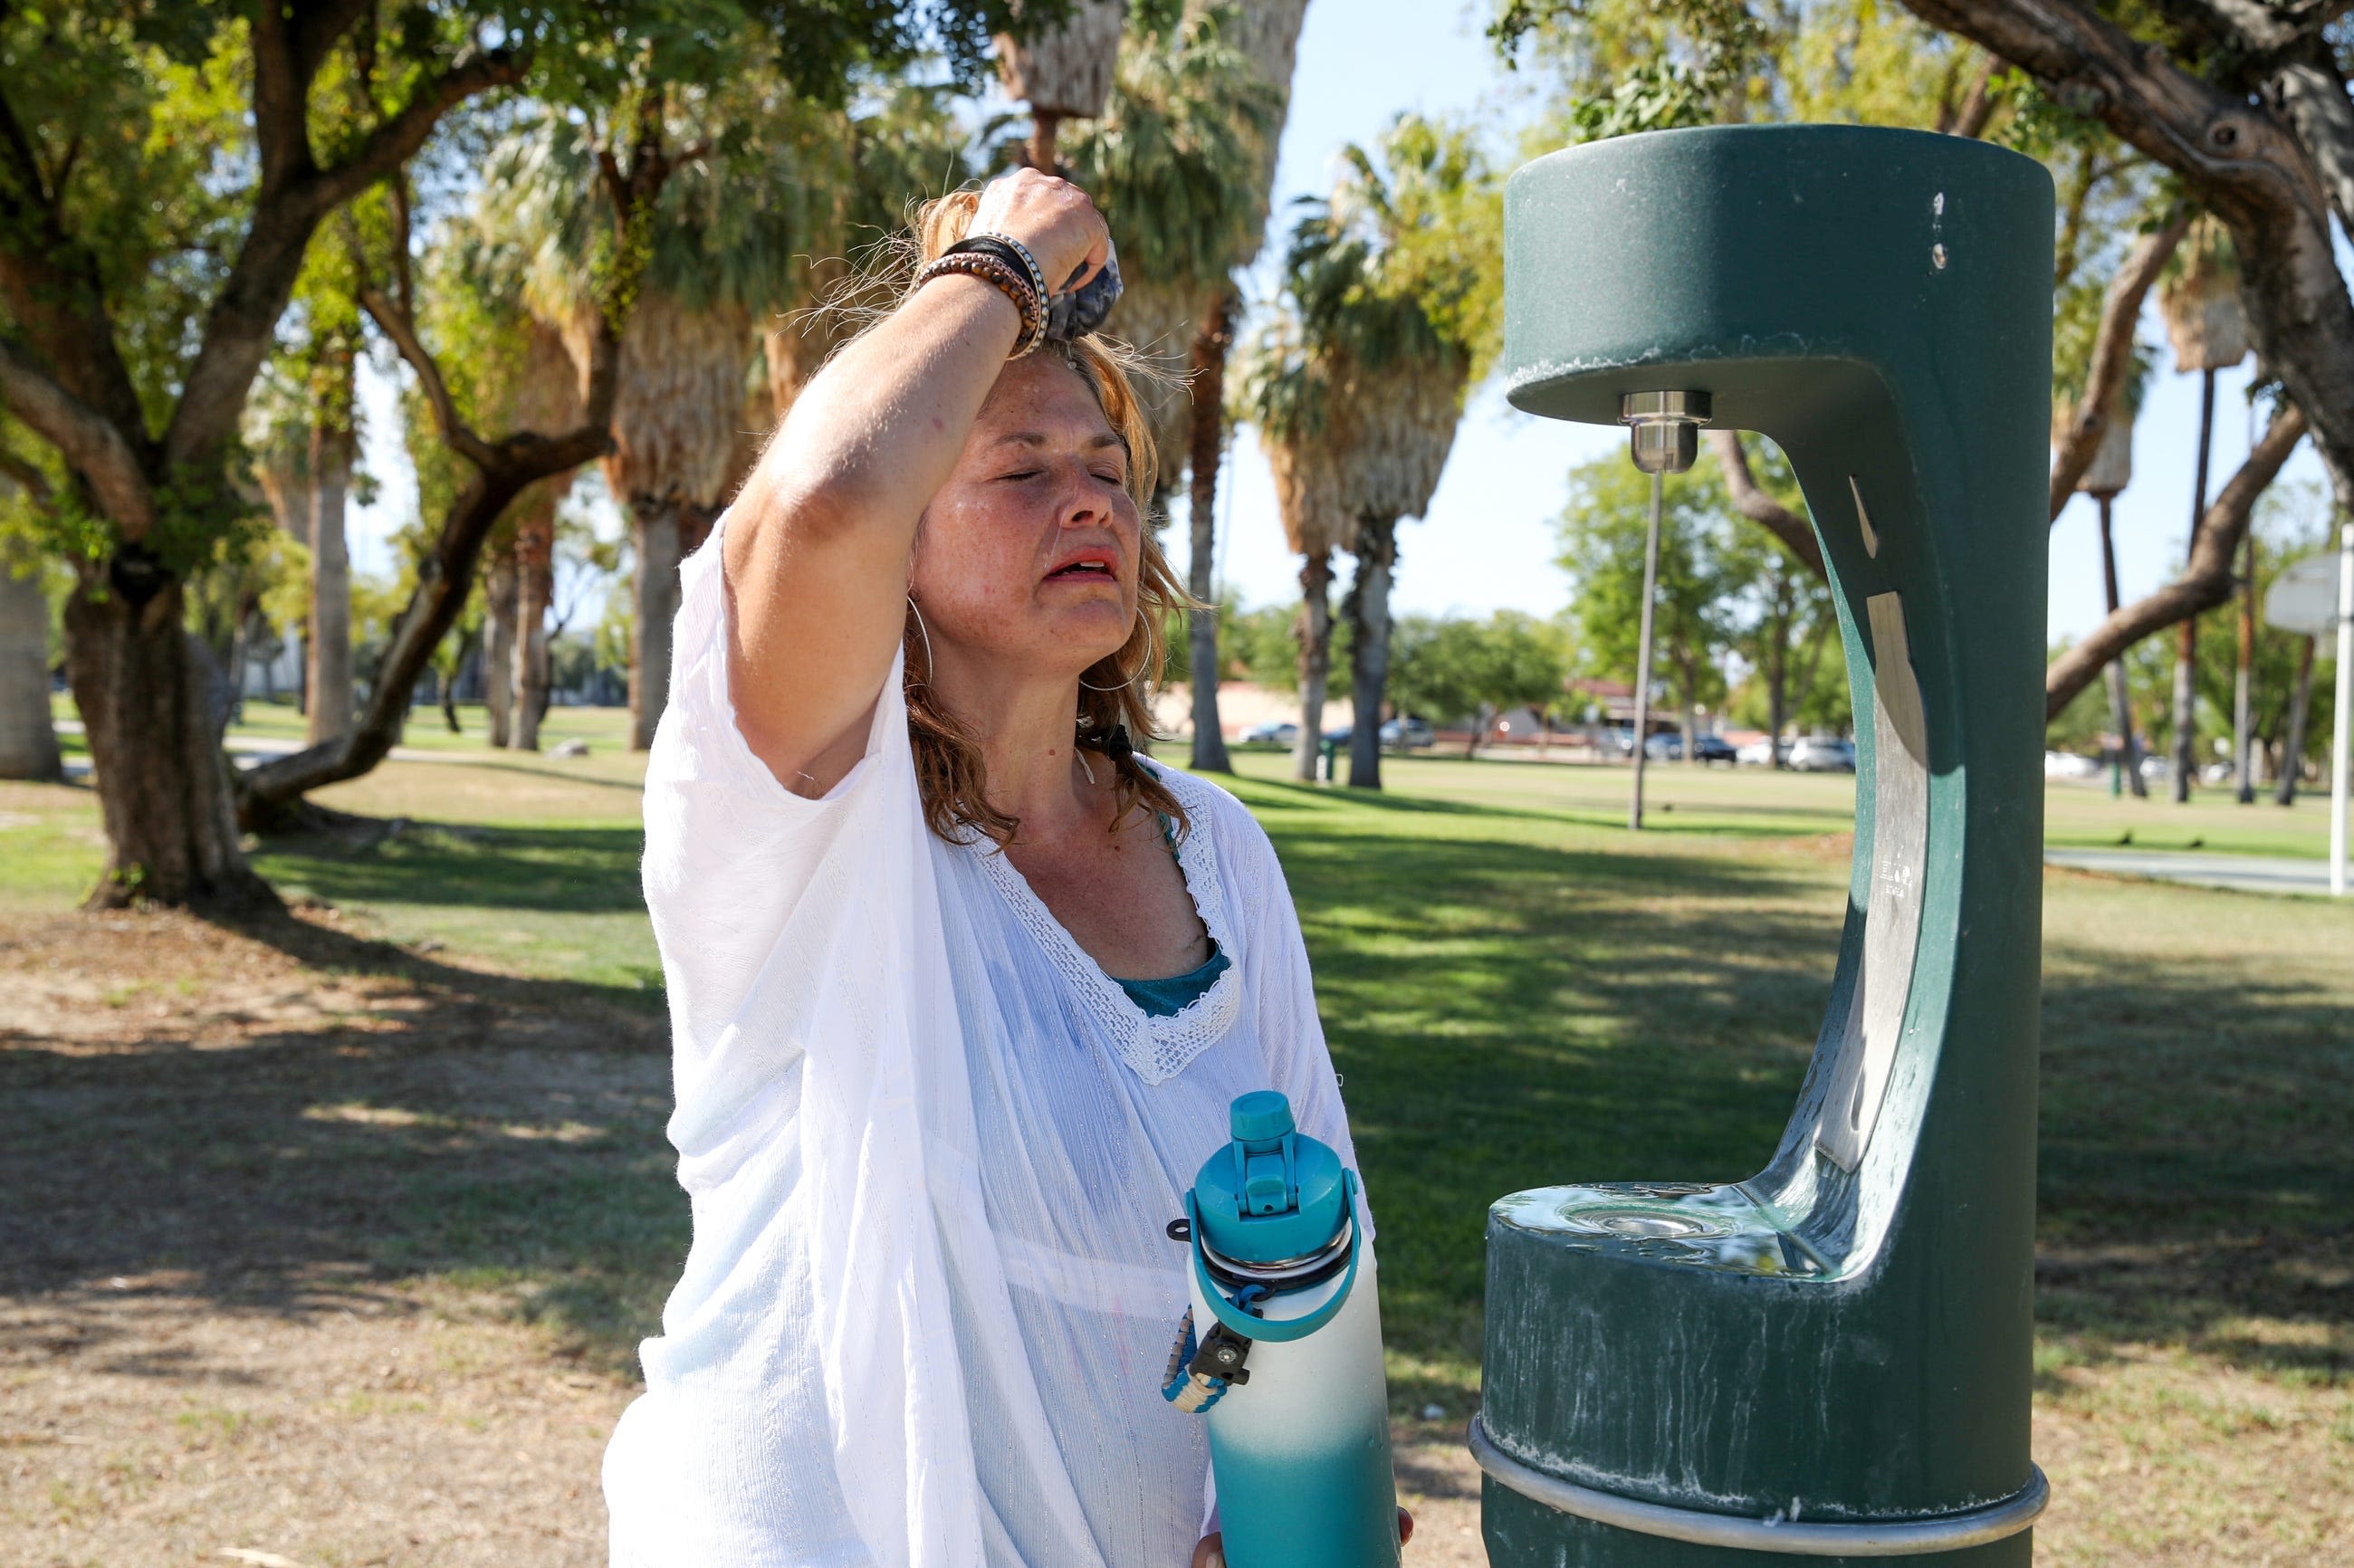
[2158,216,2255,803]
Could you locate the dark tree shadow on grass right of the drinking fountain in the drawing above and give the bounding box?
[2036,927,2354,1382]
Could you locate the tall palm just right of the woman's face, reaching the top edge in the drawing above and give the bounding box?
[1068,7,1283,772]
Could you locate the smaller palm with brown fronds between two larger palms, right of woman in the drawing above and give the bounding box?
[1233,309,1351,781]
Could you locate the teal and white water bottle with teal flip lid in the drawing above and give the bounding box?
[1163,1090,1398,1568]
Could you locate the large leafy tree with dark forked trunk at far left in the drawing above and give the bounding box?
[0,0,1062,904]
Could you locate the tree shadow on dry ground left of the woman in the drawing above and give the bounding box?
[0,916,687,1371]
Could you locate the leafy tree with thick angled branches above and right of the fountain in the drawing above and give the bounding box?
[1492,0,2316,743]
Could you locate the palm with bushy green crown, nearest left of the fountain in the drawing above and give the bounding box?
[1286,115,1502,789]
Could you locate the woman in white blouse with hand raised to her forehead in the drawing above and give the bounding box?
[605,169,1383,1568]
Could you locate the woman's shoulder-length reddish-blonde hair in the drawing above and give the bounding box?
[902,191,1203,846]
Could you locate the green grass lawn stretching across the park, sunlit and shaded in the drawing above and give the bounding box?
[0,713,2354,1561]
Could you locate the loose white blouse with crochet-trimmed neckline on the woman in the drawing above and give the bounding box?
[605,518,1356,1568]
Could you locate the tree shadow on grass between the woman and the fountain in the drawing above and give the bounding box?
[1268,817,1845,1403]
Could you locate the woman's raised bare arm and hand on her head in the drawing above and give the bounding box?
[721,169,1109,796]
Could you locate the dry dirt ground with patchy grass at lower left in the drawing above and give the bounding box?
[0,911,1483,1568]
